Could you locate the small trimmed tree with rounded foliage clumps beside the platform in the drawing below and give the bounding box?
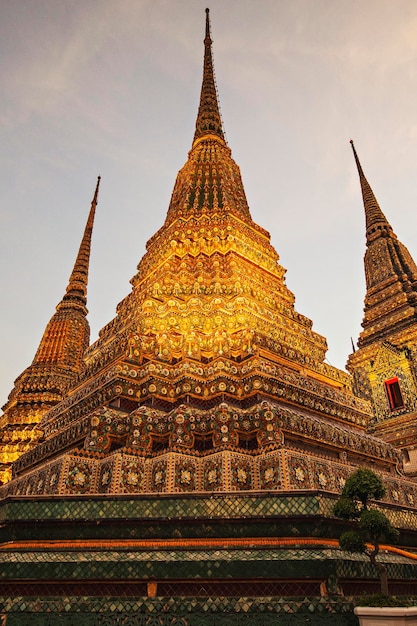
[333,469,399,596]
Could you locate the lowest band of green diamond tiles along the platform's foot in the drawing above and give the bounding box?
[0,596,357,626]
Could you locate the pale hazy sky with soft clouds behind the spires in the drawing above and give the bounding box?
[0,0,417,404]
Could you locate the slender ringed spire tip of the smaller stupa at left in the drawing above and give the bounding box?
[58,176,101,307]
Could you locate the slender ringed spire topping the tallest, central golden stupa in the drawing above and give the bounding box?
[193,9,224,143]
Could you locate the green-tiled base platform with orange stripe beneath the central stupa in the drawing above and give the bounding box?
[0,491,417,626]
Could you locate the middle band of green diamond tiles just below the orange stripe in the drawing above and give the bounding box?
[0,547,416,583]
